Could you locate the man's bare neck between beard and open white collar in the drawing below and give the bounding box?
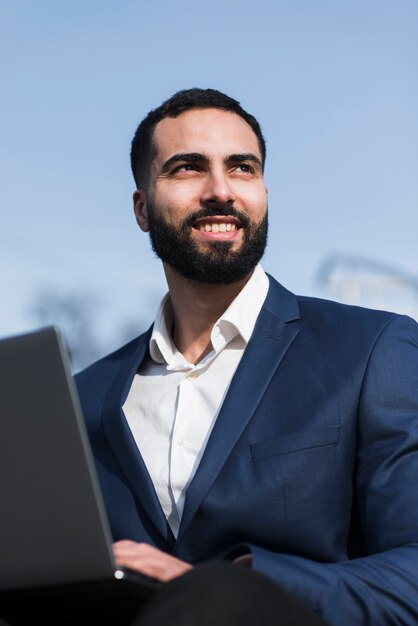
[164,264,252,364]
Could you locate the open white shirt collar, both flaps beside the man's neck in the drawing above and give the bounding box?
[149,264,269,369]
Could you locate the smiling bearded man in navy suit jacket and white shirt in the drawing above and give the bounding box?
[78,89,418,626]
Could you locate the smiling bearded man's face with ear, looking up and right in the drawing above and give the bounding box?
[134,109,267,283]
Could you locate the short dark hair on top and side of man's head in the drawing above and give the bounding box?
[131,88,266,188]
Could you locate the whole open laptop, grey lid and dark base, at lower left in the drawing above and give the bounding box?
[0,327,161,626]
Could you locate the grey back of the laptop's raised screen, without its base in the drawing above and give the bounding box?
[0,327,115,590]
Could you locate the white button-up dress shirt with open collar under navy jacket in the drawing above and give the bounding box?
[123,265,269,536]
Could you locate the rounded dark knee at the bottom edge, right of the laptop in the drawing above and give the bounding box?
[133,561,327,626]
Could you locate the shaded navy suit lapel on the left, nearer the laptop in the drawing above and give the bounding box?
[102,330,173,544]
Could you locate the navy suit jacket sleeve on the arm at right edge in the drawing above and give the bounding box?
[230,316,418,626]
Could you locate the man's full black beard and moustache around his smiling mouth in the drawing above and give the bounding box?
[148,204,268,285]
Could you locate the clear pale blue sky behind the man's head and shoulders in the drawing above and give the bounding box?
[0,0,418,358]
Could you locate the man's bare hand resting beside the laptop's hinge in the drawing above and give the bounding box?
[113,539,192,582]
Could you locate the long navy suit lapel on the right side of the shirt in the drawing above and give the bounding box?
[178,277,299,540]
